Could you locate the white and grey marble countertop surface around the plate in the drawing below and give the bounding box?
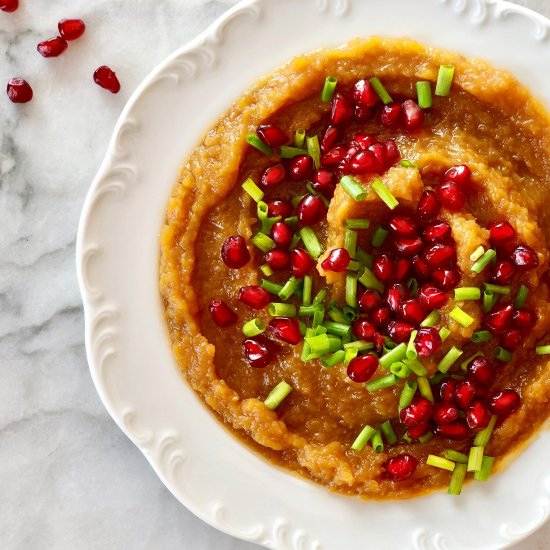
[0,0,550,550]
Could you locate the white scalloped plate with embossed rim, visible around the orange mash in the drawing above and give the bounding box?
[77,0,550,550]
